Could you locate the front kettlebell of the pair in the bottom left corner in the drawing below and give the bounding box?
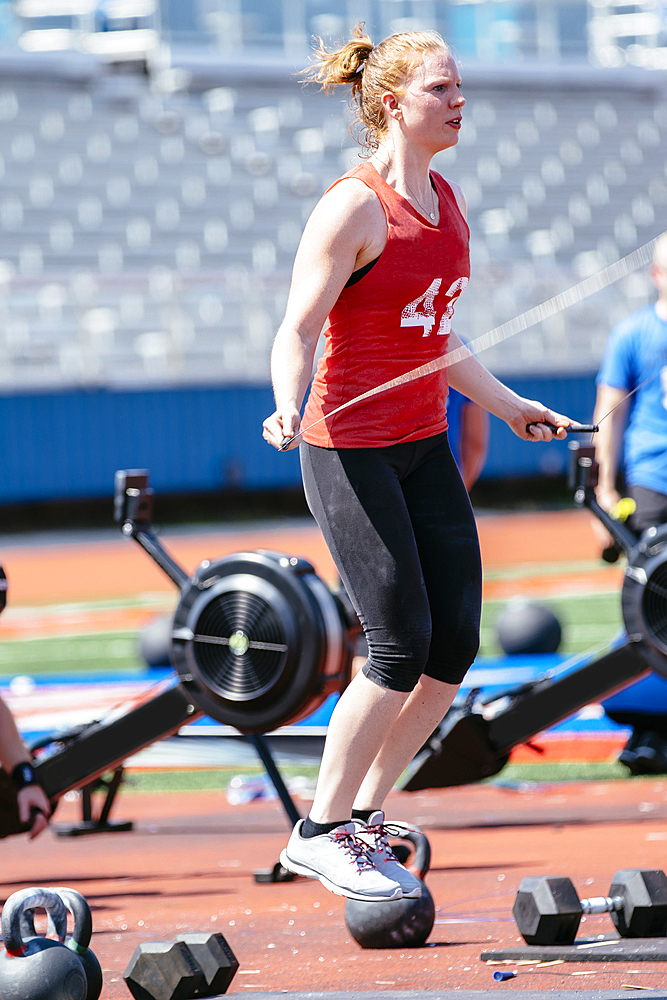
[0,888,88,1000]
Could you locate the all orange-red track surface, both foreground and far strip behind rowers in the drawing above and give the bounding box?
[0,511,667,1000]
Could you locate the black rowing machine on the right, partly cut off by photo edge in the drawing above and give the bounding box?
[399,442,667,792]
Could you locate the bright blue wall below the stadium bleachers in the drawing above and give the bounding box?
[0,375,595,504]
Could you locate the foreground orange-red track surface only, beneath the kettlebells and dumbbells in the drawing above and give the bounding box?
[2,780,667,1000]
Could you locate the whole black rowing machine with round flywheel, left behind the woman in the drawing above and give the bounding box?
[0,470,360,837]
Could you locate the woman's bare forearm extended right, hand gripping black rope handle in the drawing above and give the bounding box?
[447,330,571,441]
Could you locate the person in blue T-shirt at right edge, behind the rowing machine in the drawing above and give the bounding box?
[593,235,667,774]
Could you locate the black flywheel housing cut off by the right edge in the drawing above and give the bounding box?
[621,524,667,676]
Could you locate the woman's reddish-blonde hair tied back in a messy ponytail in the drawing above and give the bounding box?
[304,22,450,153]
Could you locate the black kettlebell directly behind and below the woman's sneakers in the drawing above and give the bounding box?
[345,827,435,948]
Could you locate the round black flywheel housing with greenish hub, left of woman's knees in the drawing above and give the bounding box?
[171,551,354,733]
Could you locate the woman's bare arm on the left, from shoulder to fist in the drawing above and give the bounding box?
[263,180,386,448]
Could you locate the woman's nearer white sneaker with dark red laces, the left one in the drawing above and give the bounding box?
[280,819,403,902]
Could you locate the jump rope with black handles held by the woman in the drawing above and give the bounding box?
[279,233,665,451]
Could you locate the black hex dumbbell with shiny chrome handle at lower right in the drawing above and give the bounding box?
[512,869,667,945]
